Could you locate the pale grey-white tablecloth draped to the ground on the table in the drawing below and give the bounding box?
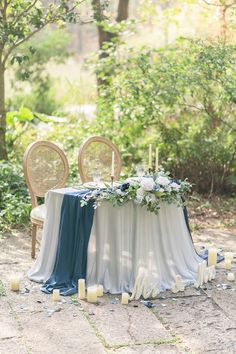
[28,188,202,294]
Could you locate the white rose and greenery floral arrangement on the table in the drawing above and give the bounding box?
[81,170,191,214]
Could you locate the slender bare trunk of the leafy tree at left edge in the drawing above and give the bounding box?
[0,58,8,160]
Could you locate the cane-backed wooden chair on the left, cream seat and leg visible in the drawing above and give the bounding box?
[23,141,69,258]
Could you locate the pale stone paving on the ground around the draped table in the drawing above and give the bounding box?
[0,229,236,354]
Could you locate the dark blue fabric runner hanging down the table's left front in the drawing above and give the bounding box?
[41,190,94,295]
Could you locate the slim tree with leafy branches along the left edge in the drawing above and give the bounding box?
[0,0,83,160]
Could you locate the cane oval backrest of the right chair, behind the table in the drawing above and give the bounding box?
[78,136,121,183]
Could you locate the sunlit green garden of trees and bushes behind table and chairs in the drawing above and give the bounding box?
[0,0,236,234]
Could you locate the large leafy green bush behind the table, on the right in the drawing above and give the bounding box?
[91,40,236,193]
